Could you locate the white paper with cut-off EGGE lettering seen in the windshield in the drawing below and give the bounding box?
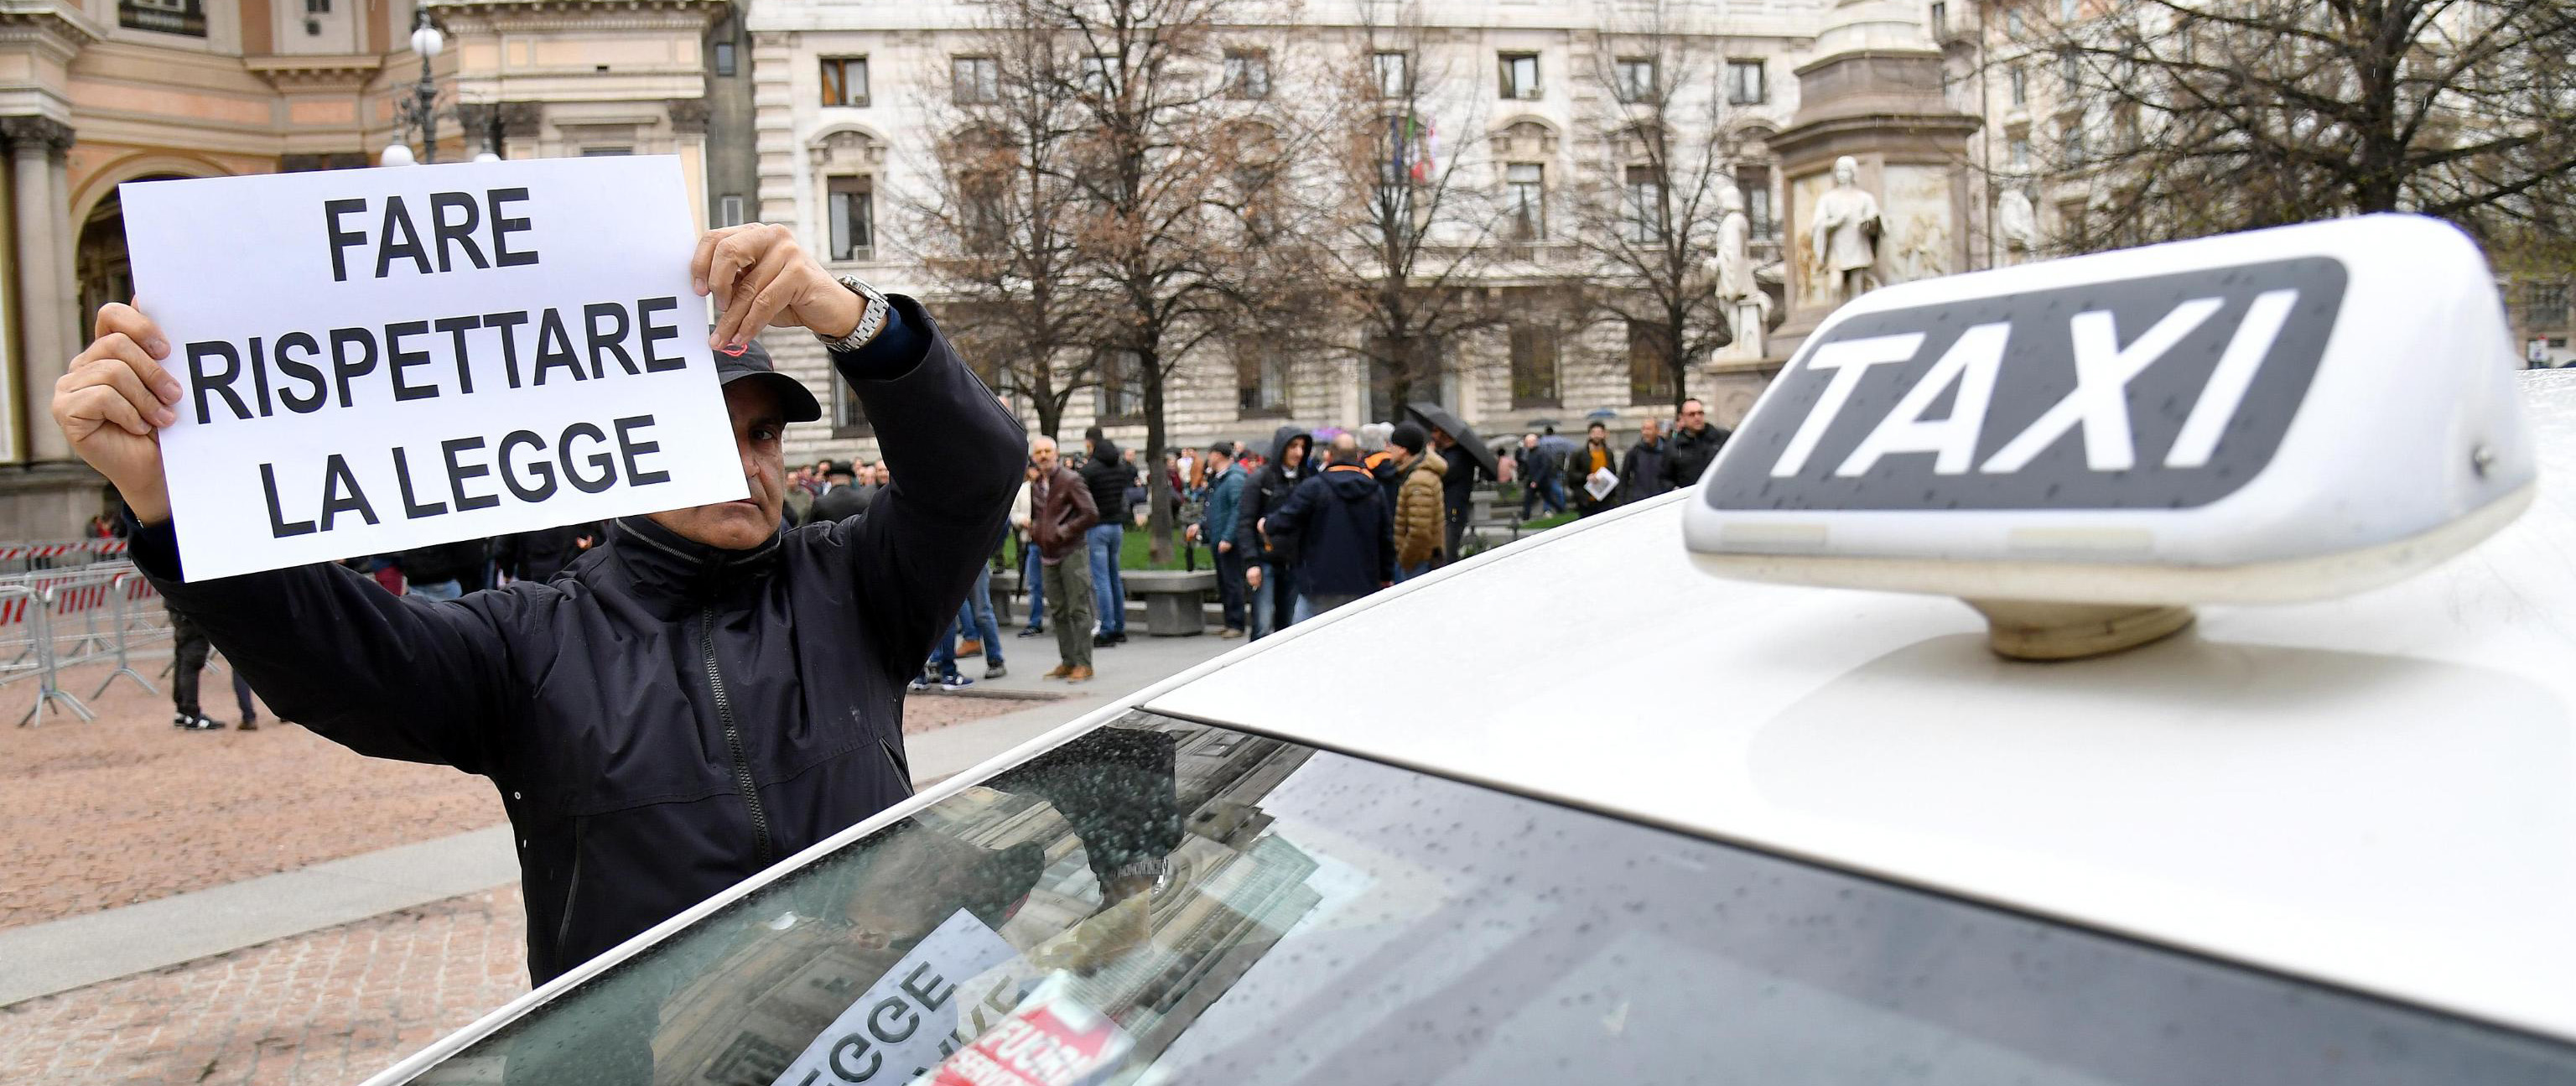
[776,908,1021,1086]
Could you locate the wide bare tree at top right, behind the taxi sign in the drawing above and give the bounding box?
[1989,0,2576,252]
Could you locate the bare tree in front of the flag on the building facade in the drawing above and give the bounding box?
[1309,3,1514,417]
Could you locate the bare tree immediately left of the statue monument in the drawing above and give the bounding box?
[1574,0,1742,409]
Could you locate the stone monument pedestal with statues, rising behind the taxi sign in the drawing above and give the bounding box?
[1769,33,1978,358]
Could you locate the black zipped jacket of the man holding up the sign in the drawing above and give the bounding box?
[134,299,1026,983]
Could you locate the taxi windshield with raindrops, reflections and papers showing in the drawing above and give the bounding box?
[397,713,2576,1086]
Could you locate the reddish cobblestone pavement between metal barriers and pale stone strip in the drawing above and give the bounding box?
[0,667,1031,931]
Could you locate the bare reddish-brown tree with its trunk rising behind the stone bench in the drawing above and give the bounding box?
[1007,0,1298,561]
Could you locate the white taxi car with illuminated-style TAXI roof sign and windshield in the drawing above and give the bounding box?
[377,219,2576,1086]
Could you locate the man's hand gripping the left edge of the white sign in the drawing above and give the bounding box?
[55,301,180,525]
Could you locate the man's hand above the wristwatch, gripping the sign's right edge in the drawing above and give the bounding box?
[688,221,868,350]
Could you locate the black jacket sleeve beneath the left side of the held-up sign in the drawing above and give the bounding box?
[132,522,520,775]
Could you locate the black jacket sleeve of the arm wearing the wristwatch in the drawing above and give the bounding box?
[824,296,1028,674]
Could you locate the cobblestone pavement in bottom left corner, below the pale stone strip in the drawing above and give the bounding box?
[0,886,528,1086]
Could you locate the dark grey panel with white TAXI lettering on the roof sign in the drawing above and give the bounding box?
[1708,257,2347,510]
